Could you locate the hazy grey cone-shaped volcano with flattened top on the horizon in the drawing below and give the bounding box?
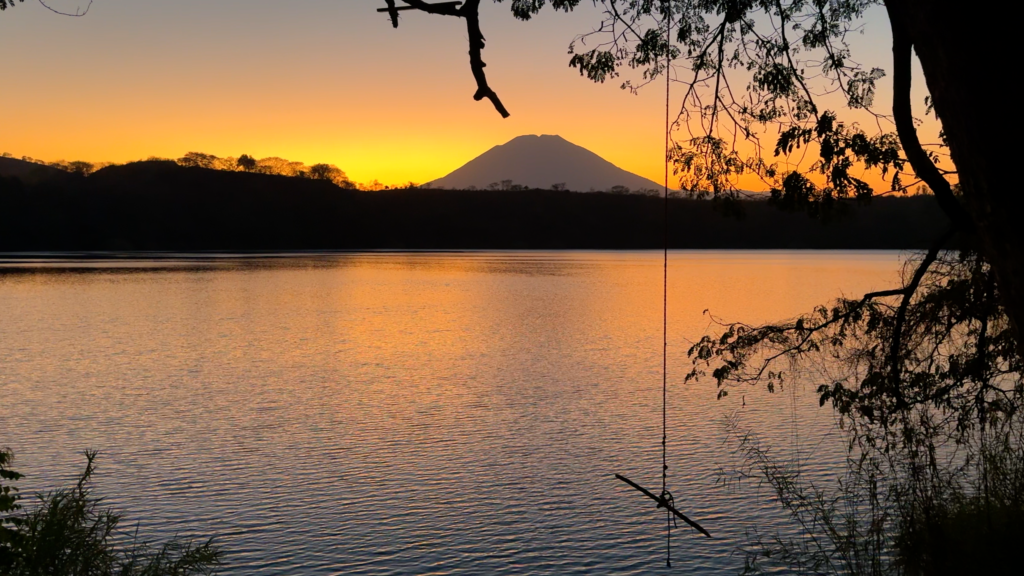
[429,134,662,192]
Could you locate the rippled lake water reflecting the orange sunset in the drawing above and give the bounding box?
[0,252,901,574]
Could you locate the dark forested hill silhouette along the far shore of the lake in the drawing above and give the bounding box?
[0,162,944,252]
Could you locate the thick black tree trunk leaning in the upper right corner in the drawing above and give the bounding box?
[886,0,1024,356]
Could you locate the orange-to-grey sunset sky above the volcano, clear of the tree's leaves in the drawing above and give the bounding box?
[0,0,937,183]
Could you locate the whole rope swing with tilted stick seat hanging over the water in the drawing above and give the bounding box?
[615,0,711,568]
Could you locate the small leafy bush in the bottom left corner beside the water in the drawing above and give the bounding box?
[0,450,221,576]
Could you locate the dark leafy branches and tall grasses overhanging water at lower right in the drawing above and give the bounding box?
[690,246,1024,575]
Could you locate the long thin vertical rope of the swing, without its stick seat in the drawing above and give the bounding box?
[662,0,672,568]
